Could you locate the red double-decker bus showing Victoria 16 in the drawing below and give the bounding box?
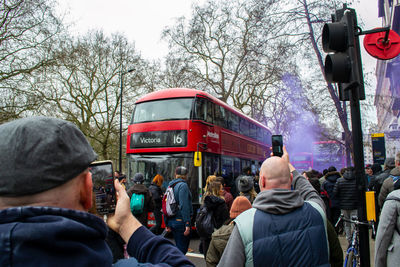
[126,88,271,209]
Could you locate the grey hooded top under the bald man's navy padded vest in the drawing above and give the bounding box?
[218,170,325,266]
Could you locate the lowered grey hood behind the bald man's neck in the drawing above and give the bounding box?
[253,189,304,214]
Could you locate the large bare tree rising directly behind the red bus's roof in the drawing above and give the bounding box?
[163,0,295,131]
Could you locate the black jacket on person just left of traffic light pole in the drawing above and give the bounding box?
[333,170,359,210]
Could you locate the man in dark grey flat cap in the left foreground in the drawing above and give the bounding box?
[0,117,193,266]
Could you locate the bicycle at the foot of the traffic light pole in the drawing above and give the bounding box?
[335,214,375,267]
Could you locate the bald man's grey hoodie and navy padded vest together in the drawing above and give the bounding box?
[218,171,329,266]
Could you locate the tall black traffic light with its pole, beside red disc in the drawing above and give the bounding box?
[322,4,370,267]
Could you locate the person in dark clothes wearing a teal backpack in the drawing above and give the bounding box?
[127,172,154,226]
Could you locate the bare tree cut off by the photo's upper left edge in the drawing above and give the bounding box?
[0,0,63,123]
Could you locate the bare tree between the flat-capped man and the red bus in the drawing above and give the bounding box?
[35,31,143,160]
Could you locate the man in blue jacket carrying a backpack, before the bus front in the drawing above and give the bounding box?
[166,166,193,254]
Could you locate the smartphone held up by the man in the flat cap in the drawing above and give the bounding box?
[89,160,117,215]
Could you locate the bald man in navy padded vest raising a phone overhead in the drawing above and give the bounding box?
[218,147,330,266]
